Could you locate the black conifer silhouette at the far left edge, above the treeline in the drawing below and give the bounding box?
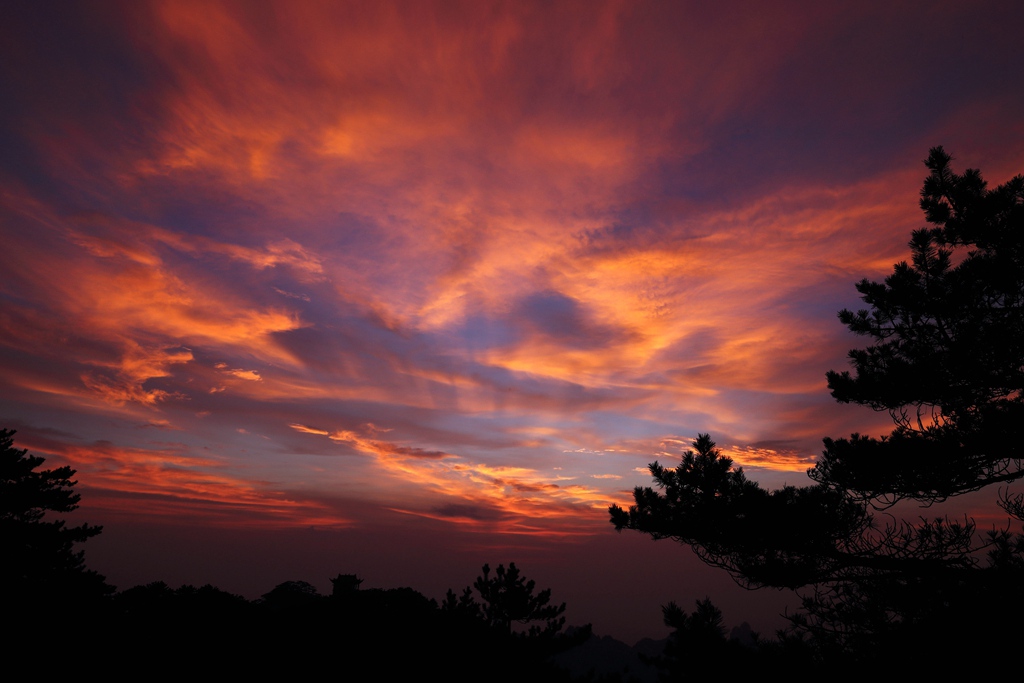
[0,429,113,611]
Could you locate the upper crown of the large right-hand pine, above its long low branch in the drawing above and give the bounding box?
[812,147,1024,504]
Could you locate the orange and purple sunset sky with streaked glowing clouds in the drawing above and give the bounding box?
[0,1,1024,640]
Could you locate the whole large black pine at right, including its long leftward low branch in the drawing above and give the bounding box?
[609,147,1024,658]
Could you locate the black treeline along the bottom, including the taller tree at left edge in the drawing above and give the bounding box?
[0,430,804,683]
